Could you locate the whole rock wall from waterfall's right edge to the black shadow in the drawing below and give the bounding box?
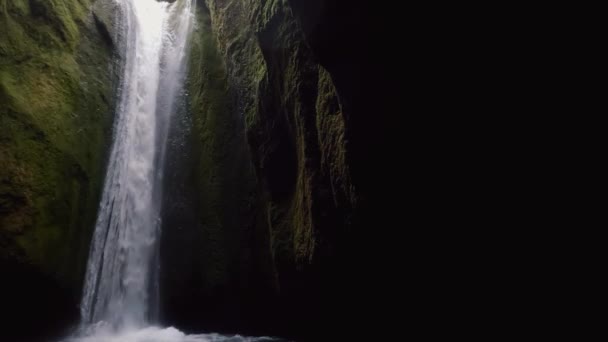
[163,0,358,335]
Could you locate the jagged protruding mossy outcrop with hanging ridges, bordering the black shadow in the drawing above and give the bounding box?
[207,0,356,277]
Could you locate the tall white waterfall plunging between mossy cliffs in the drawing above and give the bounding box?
[81,0,194,328]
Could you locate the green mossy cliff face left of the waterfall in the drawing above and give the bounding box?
[0,0,113,335]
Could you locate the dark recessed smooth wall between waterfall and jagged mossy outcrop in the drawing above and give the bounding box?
[161,3,274,331]
